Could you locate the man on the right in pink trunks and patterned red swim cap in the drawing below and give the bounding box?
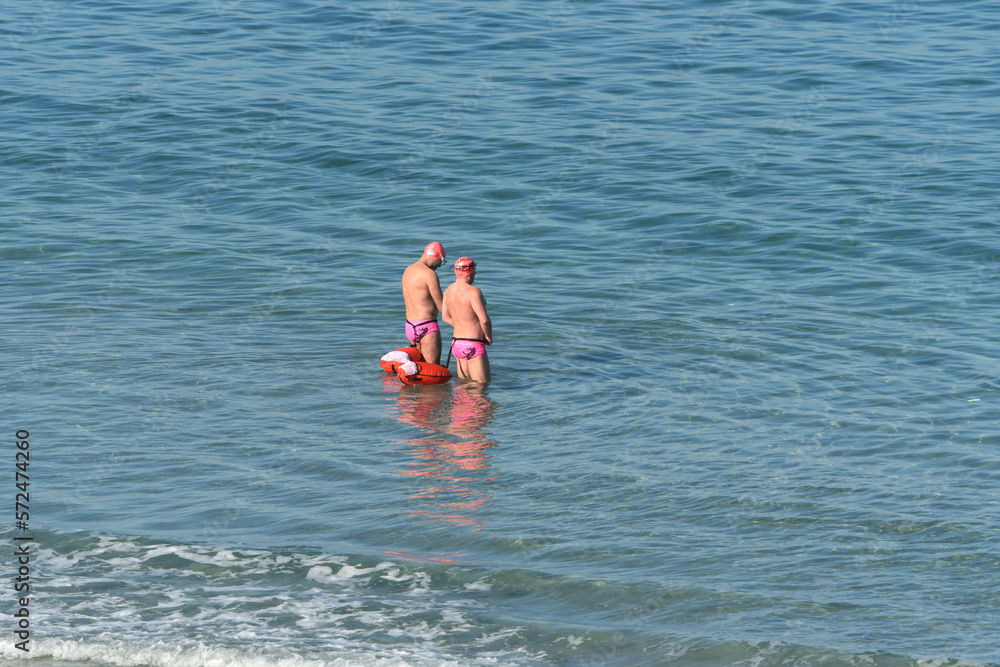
[441,257,493,382]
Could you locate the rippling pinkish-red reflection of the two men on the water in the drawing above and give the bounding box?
[384,378,497,530]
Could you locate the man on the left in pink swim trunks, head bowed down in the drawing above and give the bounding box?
[403,241,444,364]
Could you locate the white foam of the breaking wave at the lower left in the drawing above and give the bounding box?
[23,537,528,667]
